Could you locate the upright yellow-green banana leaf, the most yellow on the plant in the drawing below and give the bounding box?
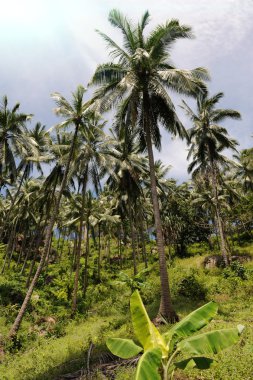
[130,290,168,357]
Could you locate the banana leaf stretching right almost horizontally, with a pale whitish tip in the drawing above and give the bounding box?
[177,325,244,355]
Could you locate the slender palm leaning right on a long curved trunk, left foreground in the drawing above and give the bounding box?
[9,86,94,337]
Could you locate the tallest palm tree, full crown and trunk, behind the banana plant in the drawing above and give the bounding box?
[91,10,208,321]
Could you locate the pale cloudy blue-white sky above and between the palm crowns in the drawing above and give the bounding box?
[0,0,253,182]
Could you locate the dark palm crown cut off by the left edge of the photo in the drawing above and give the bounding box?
[0,96,34,190]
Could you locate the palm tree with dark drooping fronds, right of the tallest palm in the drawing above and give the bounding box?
[182,92,241,265]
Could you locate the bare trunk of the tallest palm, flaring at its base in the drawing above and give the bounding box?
[145,123,178,323]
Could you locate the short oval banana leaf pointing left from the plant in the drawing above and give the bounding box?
[106,338,143,359]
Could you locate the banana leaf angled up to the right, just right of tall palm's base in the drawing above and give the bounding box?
[163,301,218,342]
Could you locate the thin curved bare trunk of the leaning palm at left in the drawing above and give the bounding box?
[9,124,79,338]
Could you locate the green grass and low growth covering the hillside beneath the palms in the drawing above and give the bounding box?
[0,239,253,380]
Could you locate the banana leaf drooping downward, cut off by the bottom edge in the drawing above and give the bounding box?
[135,347,162,380]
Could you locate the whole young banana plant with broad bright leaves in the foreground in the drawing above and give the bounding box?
[106,290,244,380]
